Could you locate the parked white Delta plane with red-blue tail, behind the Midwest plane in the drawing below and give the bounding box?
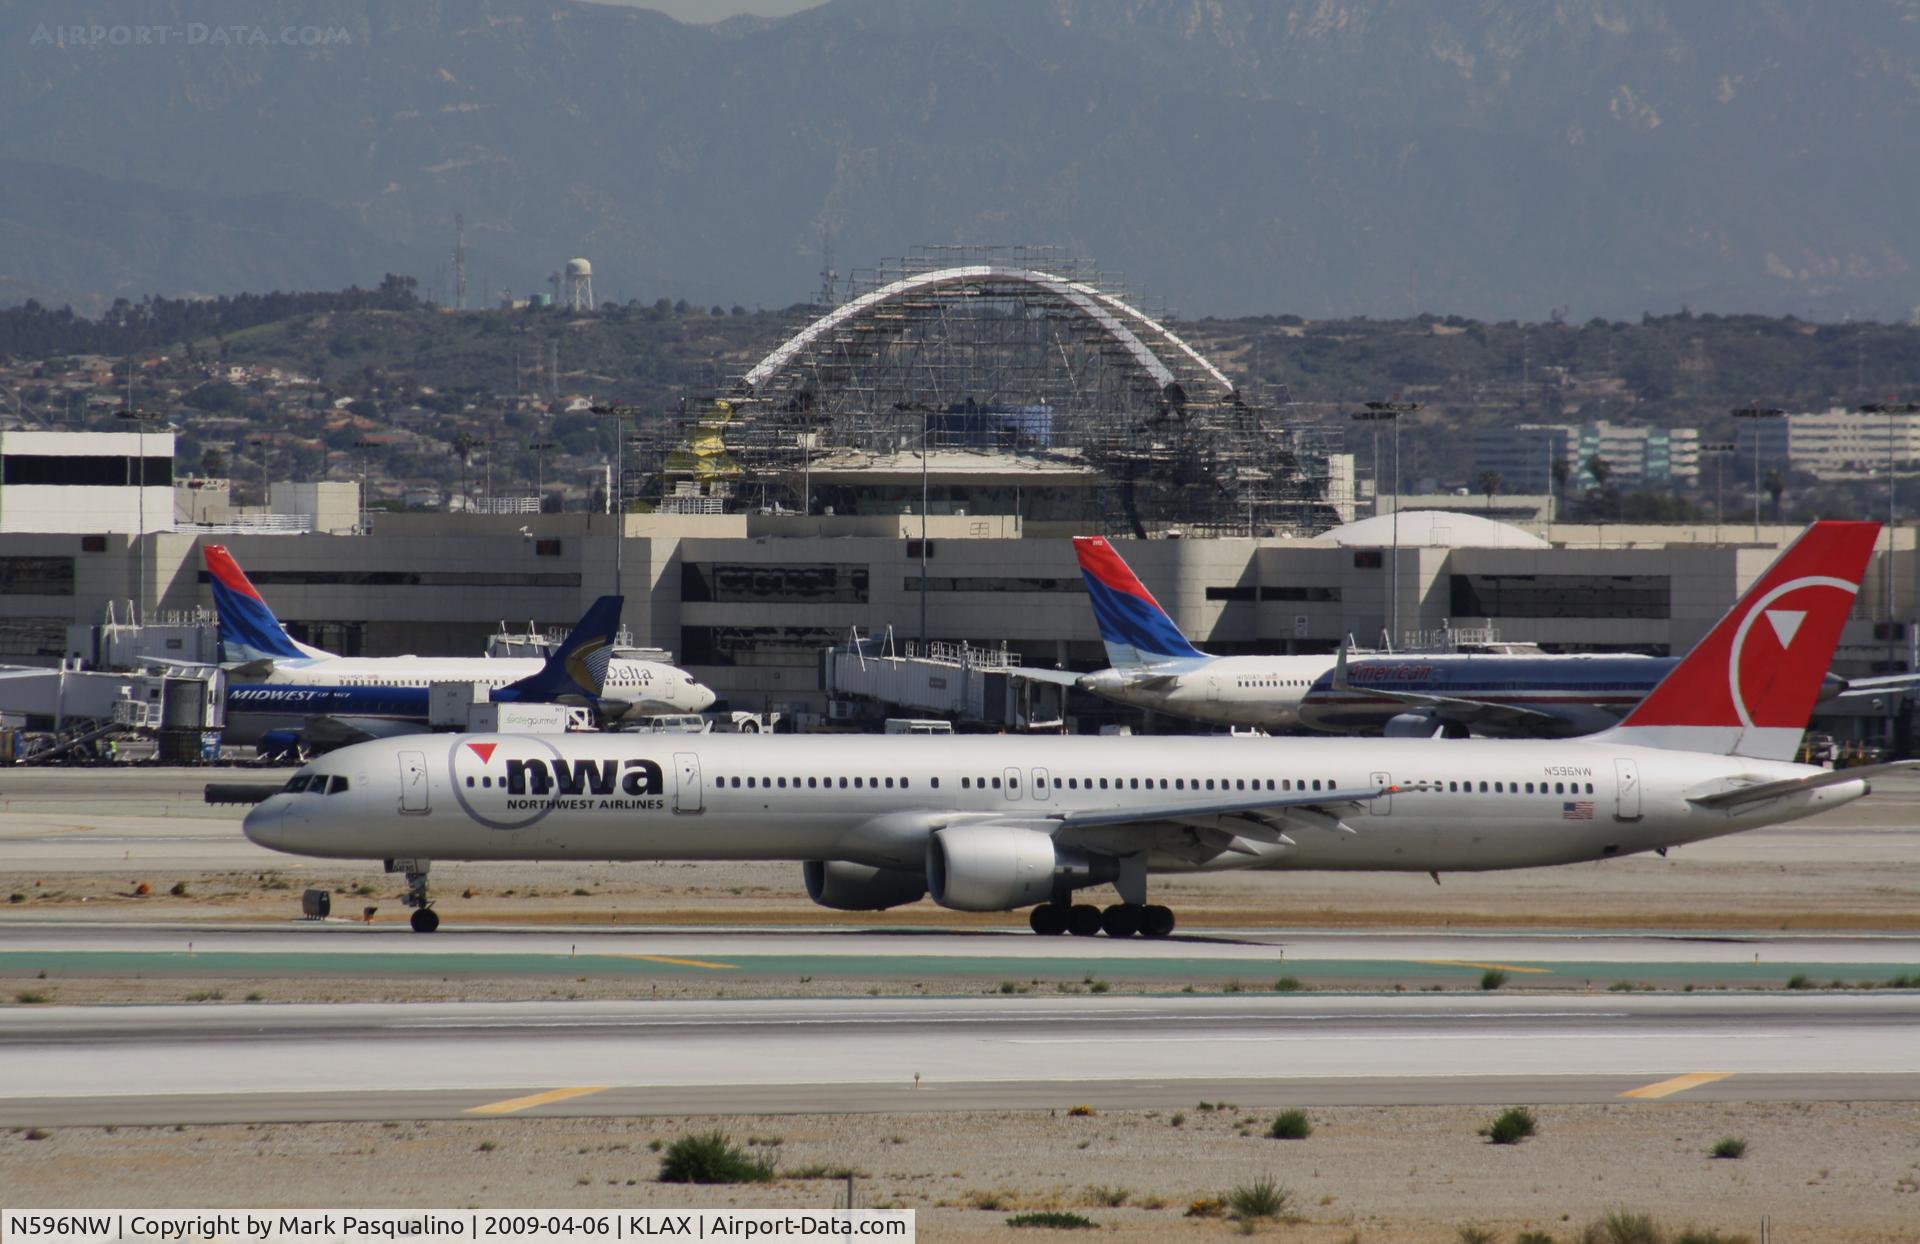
[205,545,714,716]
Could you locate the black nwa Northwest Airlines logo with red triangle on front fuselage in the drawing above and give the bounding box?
[447,735,666,829]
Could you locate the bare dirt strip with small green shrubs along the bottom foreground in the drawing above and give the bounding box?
[0,1102,1920,1244]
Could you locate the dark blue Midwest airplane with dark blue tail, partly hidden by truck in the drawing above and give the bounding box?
[221,595,620,751]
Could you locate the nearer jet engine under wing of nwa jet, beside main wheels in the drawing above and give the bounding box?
[927,825,1119,912]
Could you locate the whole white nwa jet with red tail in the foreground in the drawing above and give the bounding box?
[246,522,1916,937]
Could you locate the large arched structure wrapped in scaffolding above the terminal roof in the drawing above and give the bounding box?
[637,248,1338,538]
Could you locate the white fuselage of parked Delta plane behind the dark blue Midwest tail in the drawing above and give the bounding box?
[261,657,714,714]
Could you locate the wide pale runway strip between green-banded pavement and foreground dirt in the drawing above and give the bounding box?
[0,993,1920,1127]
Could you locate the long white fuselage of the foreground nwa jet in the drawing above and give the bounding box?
[246,735,1866,872]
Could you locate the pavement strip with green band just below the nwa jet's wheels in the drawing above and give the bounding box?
[0,920,1920,991]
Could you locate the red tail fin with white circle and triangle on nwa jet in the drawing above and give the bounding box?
[1596,522,1880,760]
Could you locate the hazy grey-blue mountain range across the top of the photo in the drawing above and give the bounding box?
[0,0,1920,321]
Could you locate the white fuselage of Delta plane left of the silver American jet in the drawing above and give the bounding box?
[1079,655,1334,730]
